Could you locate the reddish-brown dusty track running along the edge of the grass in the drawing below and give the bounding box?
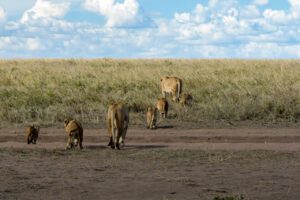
[0,128,300,151]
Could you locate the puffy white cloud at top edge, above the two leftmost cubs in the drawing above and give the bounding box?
[20,0,70,23]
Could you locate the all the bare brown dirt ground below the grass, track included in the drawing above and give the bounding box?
[0,127,300,200]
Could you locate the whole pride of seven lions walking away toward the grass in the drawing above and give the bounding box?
[25,76,193,149]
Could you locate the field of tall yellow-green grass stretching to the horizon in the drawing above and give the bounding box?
[0,59,300,125]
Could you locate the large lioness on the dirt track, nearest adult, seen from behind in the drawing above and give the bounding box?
[107,103,129,149]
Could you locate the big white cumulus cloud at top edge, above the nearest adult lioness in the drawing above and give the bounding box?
[84,0,151,27]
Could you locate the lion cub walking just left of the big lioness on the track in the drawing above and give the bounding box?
[64,119,83,149]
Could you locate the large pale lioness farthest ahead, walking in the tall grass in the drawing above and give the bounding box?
[160,76,182,102]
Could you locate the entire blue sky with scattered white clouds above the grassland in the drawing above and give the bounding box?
[0,0,300,59]
